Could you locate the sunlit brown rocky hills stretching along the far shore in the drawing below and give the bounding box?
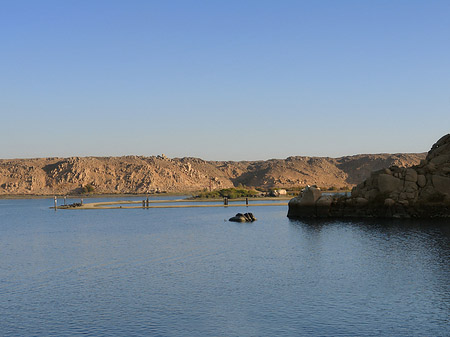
[0,153,425,195]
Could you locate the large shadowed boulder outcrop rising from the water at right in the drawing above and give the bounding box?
[288,134,450,218]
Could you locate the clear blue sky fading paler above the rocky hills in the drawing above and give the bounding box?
[0,0,450,160]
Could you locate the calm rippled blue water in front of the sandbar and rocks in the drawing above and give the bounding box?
[0,199,450,336]
